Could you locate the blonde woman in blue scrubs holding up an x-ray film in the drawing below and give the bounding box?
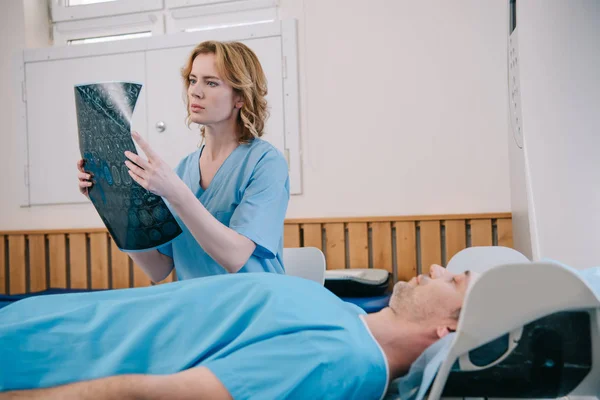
[78,41,290,282]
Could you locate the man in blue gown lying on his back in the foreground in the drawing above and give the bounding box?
[0,266,471,400]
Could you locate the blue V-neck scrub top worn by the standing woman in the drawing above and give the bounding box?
[158,138,290,280]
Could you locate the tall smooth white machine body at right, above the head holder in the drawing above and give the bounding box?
[513,0,600,268]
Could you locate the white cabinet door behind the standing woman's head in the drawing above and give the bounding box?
[145,33,285,167]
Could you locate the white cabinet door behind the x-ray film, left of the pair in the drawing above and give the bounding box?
[25,52,147,205]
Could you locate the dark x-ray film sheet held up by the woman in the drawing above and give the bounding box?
[75,82,181,251]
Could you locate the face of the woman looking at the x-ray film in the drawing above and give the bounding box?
[188,54,242,126]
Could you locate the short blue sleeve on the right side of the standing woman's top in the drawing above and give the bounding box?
[229,150,290,258]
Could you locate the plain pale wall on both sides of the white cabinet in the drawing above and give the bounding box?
[0,0,510,230]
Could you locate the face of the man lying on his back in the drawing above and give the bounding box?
[390,266,473,329]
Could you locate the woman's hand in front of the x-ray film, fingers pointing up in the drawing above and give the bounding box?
[125,132,183,200]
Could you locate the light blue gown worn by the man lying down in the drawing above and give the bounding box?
[0,273,389,400]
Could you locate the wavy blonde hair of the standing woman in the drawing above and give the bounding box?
[181,40,269,143]
